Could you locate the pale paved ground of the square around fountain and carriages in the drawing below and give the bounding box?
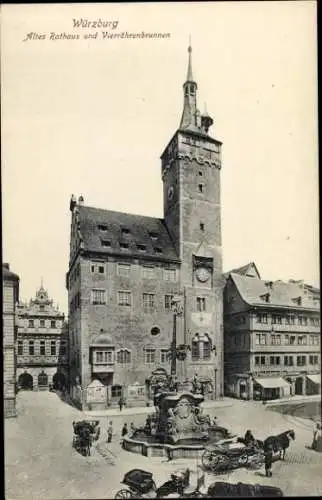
[5,392,322,500]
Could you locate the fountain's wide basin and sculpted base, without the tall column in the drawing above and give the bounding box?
[123,381,234,459]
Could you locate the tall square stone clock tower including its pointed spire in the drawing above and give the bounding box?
[161,46,224,397]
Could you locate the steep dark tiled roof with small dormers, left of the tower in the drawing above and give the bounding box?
[78,206,178,261]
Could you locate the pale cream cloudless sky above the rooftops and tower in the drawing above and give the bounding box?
[1,1,319,313]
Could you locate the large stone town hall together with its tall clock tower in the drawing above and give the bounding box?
[66,47,224,408]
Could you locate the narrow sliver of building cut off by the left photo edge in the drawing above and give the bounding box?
[2,264,19,418]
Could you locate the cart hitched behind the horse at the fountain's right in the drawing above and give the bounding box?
[201,438,264,473]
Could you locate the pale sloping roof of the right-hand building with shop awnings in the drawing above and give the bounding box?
[231,273,320,309]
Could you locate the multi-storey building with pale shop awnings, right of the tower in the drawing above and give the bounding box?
[224,263,321,399]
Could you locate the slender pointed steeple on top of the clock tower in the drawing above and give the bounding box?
[180,40,197,128]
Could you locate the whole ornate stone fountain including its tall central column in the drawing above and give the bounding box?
[123,296,230,460]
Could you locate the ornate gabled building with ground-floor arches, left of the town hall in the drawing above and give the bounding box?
[16,285,68,390]
